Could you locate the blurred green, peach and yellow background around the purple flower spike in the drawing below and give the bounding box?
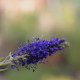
[0,0,80,80]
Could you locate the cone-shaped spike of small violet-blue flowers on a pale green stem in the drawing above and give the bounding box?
[11,37,66,69]
